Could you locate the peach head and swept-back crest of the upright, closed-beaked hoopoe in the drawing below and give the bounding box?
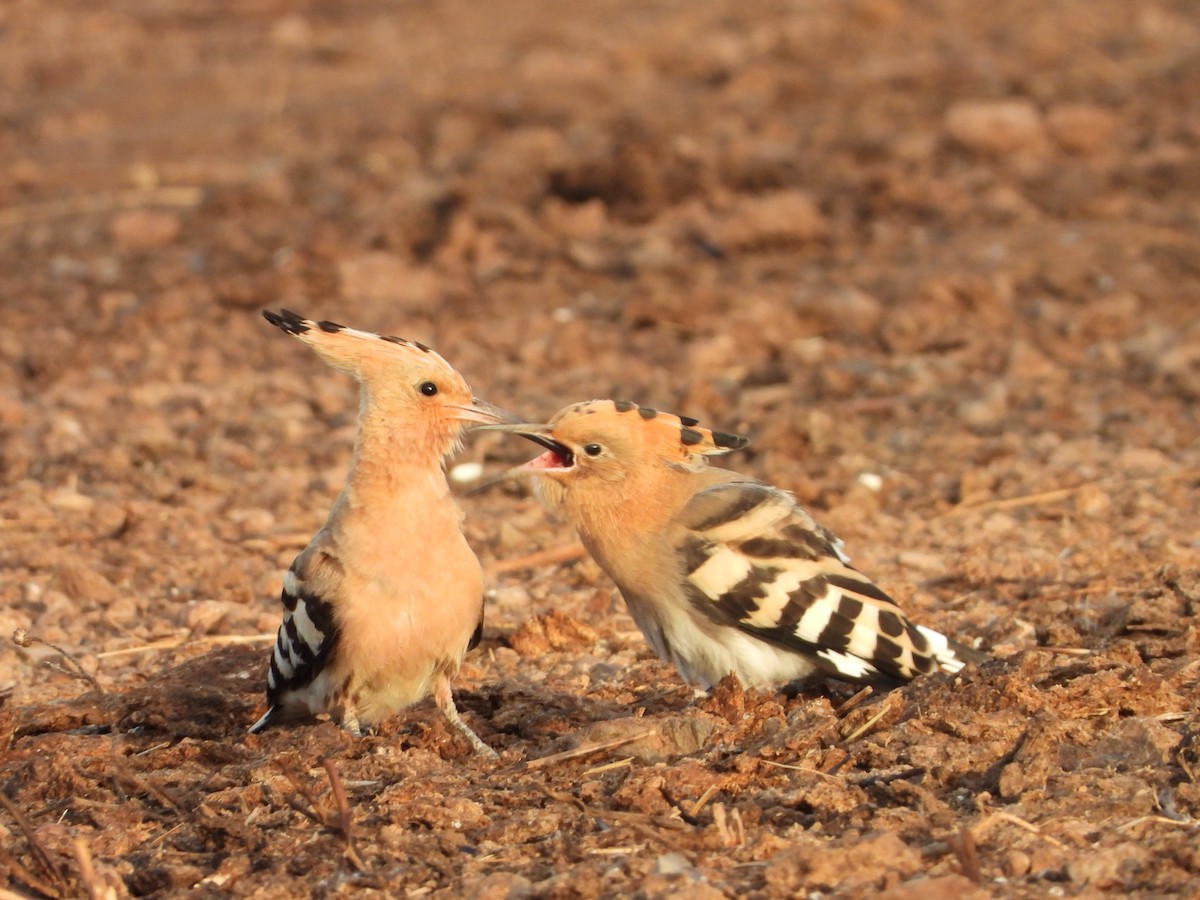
[263,310,514,455]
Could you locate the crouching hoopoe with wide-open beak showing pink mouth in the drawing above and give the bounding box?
[485,400,985,688]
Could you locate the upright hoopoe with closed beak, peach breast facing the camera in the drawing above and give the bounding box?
[250,310,512,756]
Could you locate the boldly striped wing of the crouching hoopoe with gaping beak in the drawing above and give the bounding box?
[678,481,983,683]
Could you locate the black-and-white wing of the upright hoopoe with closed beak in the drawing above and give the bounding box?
[250,535,341,732]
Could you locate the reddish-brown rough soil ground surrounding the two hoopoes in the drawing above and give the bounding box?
[0,0,1200,900]
